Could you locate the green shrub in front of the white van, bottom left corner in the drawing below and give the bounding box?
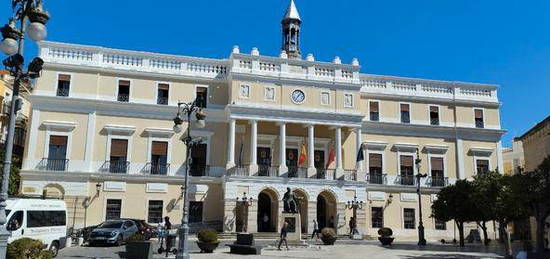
[7,238,53,259]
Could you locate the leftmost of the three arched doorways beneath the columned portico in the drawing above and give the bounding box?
[257,189,279,232]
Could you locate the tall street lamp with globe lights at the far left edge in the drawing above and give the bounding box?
[0,0,50,258]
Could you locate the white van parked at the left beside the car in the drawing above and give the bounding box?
[6,198,67,256]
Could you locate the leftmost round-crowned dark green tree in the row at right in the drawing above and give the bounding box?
[432,180,476,246]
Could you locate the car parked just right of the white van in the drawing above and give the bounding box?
[89,220,138,246]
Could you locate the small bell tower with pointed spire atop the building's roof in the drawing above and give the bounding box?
[281,0,302,59]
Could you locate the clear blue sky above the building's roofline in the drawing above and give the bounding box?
[0,0,550,146]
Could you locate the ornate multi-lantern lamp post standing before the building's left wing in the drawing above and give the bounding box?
[174,99,206,259]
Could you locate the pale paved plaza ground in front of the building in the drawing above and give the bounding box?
[58,241,503,259]
